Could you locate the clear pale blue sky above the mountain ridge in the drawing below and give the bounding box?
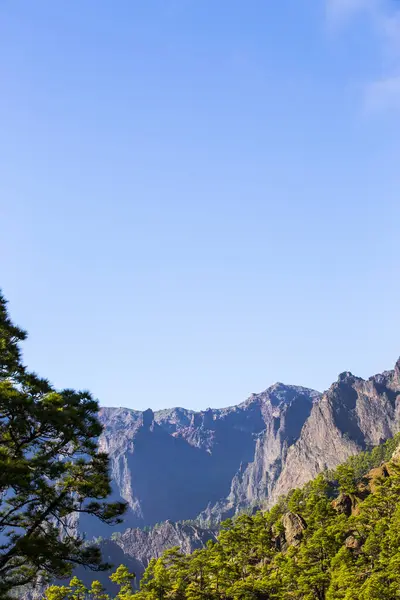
[0,0,400,409]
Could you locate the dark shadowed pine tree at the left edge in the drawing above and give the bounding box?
[0,294,125,600]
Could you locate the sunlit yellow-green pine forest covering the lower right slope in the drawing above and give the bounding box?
[46,436,400,600]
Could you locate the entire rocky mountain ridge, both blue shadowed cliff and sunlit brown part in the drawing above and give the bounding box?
[97,361,400,534]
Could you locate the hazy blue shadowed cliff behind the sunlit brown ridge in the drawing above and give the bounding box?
[97,384,320,531]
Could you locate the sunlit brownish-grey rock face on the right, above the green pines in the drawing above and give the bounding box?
[269,361,400,504]
